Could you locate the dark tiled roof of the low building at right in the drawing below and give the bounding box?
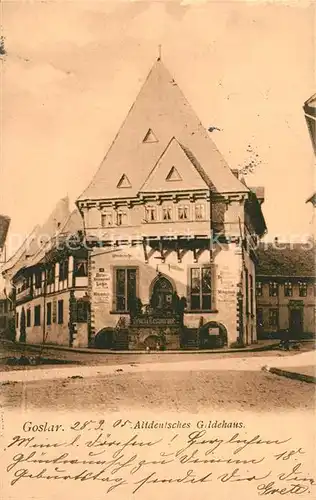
[256,242,315,278]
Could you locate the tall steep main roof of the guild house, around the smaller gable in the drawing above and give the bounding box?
[78,60,248,201]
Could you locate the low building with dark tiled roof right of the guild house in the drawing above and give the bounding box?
[256,241,316,337]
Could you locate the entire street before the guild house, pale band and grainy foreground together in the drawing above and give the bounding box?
[1,344,315,413]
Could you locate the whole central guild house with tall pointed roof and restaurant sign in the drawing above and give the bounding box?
[77,60,266,349]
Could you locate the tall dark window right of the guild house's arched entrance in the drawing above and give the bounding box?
[190,267,212,311]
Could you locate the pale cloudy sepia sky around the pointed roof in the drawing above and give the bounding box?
[0,0,316,253]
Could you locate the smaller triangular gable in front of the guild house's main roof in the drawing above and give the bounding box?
[140,137,209,193]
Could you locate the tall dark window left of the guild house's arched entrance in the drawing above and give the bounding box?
[114,267,137,312]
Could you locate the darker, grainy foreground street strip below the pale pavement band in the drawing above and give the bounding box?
[1,370,314,413]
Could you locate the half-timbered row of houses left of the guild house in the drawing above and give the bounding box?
[3,199,89,346]
